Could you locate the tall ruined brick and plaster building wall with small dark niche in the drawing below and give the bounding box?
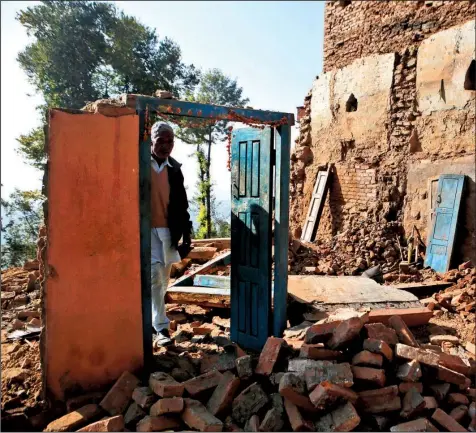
[290,1,476,270]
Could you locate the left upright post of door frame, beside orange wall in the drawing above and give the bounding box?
[138,111,153,374]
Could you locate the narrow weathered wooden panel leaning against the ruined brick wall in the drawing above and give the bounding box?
[301,164,332,242]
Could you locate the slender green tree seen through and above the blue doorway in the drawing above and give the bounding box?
[177,69,249,238]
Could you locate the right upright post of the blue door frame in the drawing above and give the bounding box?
[273,125,291,337]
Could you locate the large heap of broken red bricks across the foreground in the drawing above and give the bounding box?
[39,310,476,431]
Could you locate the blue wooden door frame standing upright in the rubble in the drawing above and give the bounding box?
[128,95,294,364]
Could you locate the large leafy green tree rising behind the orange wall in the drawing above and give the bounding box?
[17,0,198,169]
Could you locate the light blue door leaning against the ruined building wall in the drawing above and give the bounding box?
[425,174,465,272]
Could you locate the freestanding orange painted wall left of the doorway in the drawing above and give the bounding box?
[43,110,143,399]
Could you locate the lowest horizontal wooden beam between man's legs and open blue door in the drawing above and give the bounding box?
[165,286,230,308]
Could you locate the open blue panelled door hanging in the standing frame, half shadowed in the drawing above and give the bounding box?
[230,128,273,350]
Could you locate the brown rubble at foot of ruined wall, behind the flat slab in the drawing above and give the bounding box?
[289,221,403,275]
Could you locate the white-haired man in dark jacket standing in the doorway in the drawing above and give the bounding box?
[150,122,192,346]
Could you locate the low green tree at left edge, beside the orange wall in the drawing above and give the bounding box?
[1,189,44,269]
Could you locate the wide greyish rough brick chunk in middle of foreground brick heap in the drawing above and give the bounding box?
[304,361,354,391]
